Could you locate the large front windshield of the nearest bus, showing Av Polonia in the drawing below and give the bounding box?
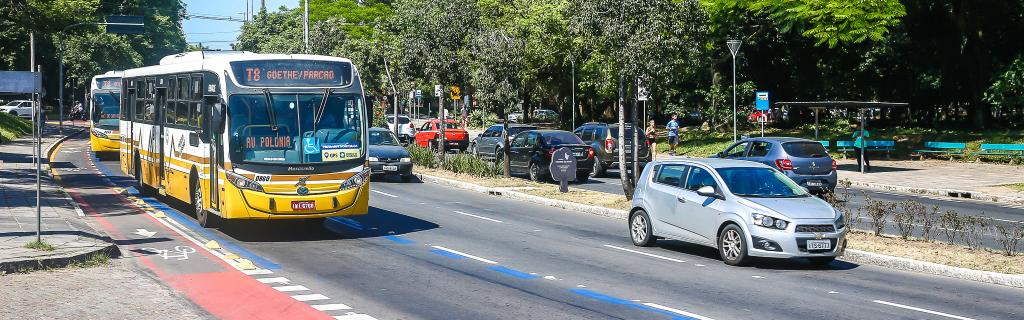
[227,93,365,164]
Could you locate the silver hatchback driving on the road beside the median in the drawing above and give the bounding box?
[629,158,847,266]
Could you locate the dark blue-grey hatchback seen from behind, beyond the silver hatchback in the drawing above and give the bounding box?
[714,137,837,194]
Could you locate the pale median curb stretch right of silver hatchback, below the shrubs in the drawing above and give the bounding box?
[843,249,1024,288]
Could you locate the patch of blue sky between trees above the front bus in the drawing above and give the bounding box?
[182,0,301,50]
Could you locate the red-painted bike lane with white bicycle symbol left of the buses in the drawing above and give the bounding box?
[50,137,332,319]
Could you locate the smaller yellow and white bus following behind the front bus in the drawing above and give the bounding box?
[88,71,123,158]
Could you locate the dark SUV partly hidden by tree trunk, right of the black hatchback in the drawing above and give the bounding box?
[572,122,650,177]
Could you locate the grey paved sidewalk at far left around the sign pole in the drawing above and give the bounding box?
[0,121,117,274]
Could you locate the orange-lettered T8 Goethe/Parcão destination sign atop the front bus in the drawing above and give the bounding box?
[231,59,352,87]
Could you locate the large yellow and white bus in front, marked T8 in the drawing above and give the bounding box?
[121,51,370,227]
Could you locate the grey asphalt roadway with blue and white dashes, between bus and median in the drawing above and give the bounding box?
[81,148,1024,319]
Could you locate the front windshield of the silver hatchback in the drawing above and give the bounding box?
[715,167,807,198]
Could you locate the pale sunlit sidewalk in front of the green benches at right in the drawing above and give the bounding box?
[838,159,1024,205]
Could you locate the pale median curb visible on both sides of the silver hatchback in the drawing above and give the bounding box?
[416,173,1024,288]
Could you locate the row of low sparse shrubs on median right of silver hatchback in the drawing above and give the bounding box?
[825,181,1024,256]
